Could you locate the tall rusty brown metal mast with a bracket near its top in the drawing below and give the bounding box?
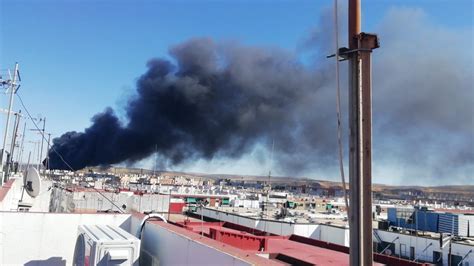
[344,0,379,265]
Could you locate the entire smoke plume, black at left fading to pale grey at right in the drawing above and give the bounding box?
[50,8,474,185]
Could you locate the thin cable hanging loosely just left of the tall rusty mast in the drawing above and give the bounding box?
[334,0,349,213]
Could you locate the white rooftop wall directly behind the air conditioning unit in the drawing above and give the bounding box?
[0,212,131,265]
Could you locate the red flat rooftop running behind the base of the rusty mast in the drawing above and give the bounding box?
[170,221,429,266]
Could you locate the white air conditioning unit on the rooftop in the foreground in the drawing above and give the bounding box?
[73,225,140,266]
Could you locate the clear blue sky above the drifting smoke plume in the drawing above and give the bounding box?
[0,0,473,184]
